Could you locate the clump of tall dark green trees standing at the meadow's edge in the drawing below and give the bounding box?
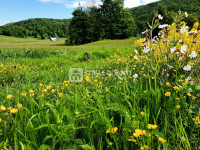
[66,0,136,45]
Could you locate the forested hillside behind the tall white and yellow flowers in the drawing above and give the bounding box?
[130,0,200,33]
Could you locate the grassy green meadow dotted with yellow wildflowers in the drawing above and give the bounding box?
[0,20,200,150]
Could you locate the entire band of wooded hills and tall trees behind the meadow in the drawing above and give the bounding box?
[0,0,200,41]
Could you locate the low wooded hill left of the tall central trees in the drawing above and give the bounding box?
[0,18,70,39]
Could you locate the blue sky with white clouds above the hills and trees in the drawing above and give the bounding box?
[0,0,158,25]
